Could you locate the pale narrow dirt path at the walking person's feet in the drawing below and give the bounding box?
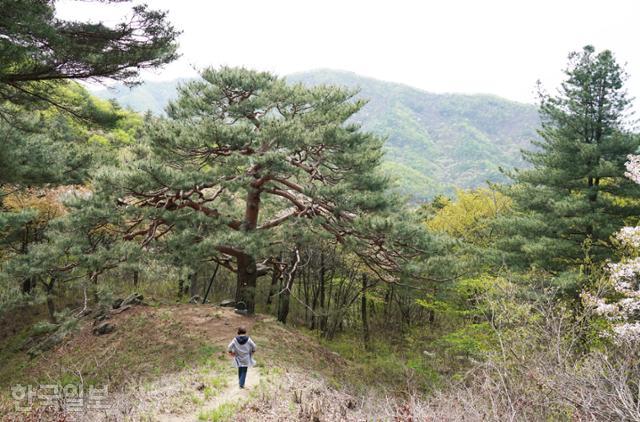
[157,368,261,422]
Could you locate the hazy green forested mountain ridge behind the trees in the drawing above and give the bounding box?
[95,70,540,201]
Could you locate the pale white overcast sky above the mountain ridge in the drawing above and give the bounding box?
[57,0,640,108]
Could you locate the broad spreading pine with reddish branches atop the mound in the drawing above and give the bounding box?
[81,68,436,312]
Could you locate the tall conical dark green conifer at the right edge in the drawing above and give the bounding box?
[499,46,640,272]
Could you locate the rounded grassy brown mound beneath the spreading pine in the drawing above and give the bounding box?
[0,305,356,419]
